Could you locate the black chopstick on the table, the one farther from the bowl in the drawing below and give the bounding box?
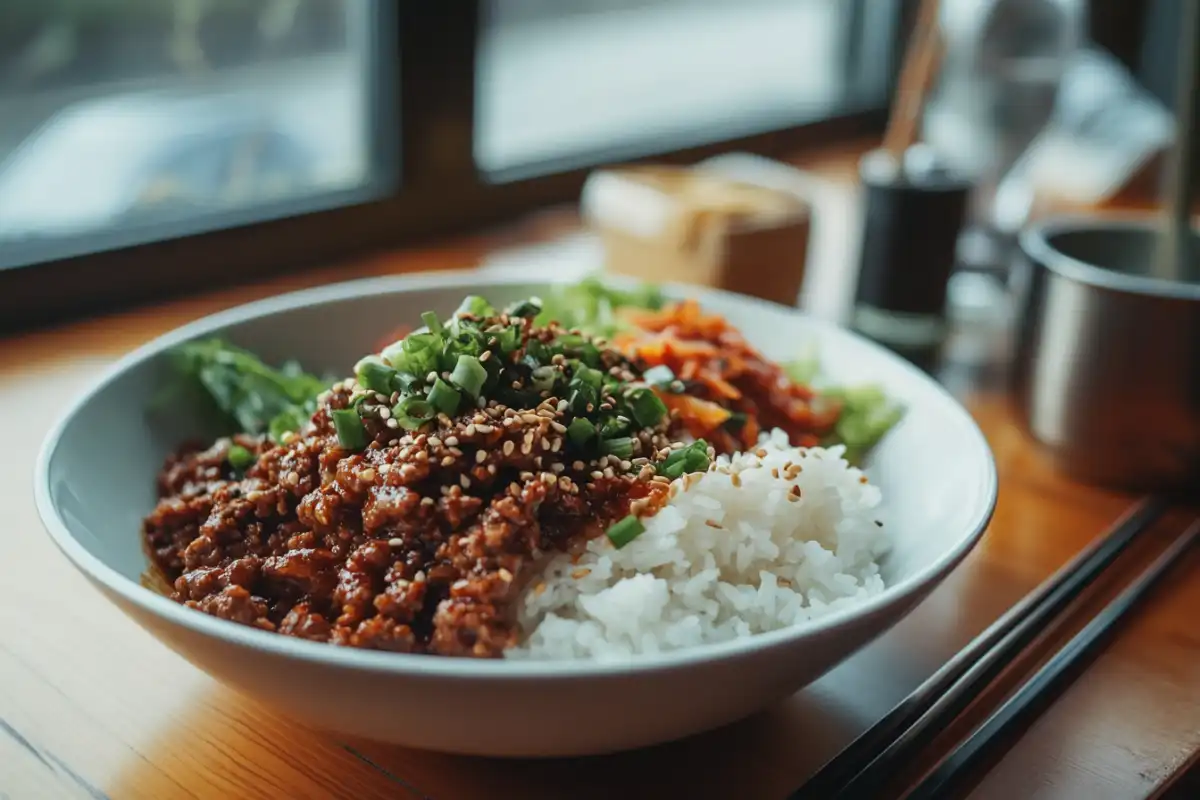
[905,521,1200,800]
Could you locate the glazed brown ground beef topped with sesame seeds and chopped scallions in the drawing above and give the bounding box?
[143,313,679,657]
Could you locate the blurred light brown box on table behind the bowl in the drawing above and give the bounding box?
[581,166,811,306]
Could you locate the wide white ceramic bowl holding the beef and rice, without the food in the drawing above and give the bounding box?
[36,273,996,756]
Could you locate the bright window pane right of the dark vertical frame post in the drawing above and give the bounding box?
[475,0,895,180]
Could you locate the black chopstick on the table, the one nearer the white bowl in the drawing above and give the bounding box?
[791,498,1168,800]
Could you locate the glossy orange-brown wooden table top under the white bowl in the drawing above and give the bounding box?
[0,151,1200,800]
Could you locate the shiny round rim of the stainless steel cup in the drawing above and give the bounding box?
[1019,212,1200,301]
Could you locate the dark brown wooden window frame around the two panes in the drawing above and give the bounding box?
[0,0,916,332]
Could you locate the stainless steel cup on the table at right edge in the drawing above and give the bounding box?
[1013,218,1200,491]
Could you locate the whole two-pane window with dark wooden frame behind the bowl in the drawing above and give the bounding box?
[0,0,905,329]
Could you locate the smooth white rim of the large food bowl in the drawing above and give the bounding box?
[34,269,998,680]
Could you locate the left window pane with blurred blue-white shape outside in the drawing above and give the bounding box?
[0,0,372,242]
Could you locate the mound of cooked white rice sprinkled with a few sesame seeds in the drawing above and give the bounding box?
[508,431,888,660]
